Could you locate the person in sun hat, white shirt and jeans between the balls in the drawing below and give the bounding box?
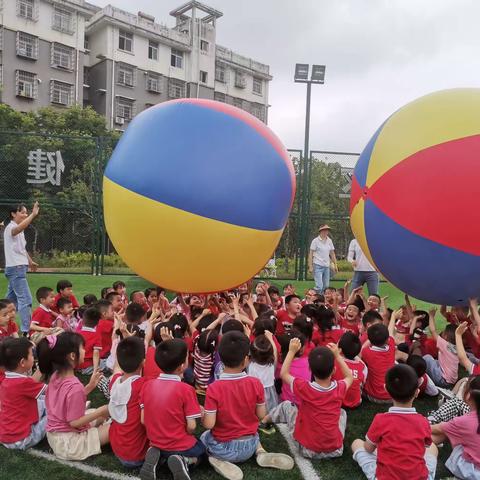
[308,225,337,293]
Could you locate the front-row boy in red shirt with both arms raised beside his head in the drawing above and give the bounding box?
[263,338,353,459]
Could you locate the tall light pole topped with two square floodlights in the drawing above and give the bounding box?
[294,63,326,280]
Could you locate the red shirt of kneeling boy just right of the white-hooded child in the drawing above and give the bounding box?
[140,373,201,452]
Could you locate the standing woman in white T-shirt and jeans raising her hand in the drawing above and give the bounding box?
[3,202,40,333]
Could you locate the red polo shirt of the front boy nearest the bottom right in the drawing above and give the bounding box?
[366,407,432,480]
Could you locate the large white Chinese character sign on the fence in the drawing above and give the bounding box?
[27,148,65,187]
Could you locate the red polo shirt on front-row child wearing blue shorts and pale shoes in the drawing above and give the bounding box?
[205,372,265,442]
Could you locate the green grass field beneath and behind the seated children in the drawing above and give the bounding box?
[0,274,450,480]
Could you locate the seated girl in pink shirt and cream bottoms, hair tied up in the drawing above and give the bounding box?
[37,332,110,460]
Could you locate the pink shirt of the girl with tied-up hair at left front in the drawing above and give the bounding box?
[45,372,90,432]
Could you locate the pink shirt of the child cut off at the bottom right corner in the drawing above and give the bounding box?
[440,411,480,469]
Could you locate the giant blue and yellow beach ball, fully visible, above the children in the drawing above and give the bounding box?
[103,99,295,293]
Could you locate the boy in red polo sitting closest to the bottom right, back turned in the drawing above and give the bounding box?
[352,364,438,480]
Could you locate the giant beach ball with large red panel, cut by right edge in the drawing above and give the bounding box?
[350,89,480,305]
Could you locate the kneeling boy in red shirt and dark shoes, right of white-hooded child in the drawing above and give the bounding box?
[140,338,205,480]
